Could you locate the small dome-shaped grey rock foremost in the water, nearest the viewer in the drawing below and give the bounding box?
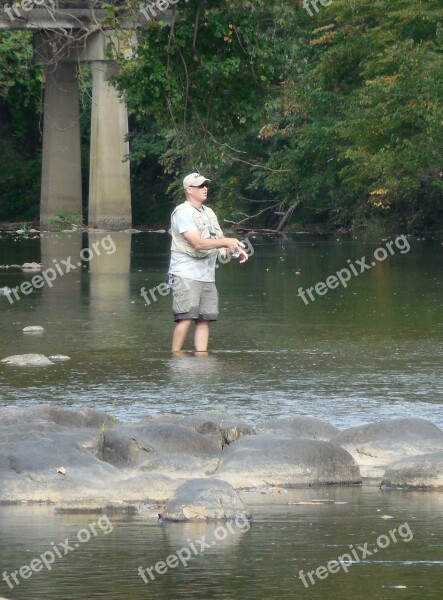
[161,479,249,521]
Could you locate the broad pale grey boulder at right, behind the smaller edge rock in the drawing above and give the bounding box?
[331,417,443,478]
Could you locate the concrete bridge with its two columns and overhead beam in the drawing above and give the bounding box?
[0,0,142,230]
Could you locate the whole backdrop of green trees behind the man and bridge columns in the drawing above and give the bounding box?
[0,0,443,232]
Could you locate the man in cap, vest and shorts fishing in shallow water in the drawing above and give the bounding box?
[168,173,248,352]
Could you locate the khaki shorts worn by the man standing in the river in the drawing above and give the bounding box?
[168,275,218,321]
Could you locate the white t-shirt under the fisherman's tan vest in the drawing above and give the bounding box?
[168,207,218,282]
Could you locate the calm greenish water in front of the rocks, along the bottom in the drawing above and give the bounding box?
[0,488,443,600]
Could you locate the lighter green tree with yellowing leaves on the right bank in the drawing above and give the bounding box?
[255,0,443,231]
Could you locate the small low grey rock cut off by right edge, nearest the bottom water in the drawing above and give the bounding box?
[381,452,443,490]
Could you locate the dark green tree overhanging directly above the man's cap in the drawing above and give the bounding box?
[118,0,294,220]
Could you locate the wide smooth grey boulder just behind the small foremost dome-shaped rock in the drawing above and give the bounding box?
[214,434,361,488]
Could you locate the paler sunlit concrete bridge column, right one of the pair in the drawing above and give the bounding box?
[88,60,132,230]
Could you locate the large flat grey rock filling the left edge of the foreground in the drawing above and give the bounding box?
[0,405,185,507]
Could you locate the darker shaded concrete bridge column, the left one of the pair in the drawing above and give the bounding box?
[40,62,82,229]
